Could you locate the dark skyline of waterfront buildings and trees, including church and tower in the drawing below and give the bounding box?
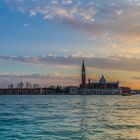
[0,60,133,95]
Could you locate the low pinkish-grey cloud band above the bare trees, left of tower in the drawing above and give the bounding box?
[0,72,79,88]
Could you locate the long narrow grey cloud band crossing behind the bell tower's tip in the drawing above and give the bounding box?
[0,56,140,71]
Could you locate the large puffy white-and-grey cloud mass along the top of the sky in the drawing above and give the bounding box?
[2,0,140,42]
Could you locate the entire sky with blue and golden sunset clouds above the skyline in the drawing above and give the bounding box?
[0,0,140,89]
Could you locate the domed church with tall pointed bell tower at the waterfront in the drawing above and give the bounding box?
[80,61,120,95]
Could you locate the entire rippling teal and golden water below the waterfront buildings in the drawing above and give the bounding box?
[0,95,140,140]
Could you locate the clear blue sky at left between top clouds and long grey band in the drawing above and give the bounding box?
[0,2,93,55]
